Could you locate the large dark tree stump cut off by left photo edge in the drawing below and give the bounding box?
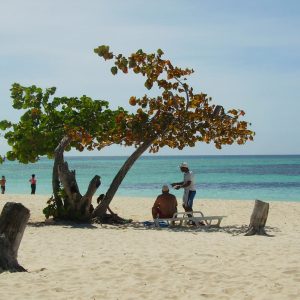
[0,202,30,273]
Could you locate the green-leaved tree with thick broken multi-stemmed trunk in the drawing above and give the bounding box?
[0,83,127,220]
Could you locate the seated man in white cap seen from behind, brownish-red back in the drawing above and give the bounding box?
[152,185,177,219]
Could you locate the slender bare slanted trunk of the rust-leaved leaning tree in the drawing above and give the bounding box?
[93,139,153,219]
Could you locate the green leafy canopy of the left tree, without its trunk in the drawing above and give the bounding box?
[0,83,127,163]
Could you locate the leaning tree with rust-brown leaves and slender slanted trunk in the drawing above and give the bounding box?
[94,45,254,216]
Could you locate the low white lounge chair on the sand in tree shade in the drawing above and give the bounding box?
[154,211,226,227]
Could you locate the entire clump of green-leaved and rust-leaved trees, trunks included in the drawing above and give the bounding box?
[0,45,254,219]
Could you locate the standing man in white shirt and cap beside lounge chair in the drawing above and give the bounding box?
[172,162,196,211]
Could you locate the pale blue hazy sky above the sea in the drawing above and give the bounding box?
[0,0,300,155]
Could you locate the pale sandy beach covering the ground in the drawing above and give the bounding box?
[0,195,300,300]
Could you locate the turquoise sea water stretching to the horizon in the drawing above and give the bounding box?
[0,155,300,201]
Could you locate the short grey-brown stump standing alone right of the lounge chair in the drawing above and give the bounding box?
[245,200,269,236]
